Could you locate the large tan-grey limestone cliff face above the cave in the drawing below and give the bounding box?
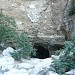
[0,0,67,43]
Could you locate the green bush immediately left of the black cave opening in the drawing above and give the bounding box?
[14,32,36,58]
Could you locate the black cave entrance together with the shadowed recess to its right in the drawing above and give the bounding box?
[33,43,64,59]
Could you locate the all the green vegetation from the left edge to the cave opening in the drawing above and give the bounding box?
[0,12,36,60]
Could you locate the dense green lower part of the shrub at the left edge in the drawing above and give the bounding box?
[0,24,16,43]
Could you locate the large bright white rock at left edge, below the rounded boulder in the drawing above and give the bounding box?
[0,56,14,71]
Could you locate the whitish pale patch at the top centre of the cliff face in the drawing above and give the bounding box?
[27,0,47,23]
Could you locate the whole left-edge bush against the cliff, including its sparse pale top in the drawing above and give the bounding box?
[0,12,16,43]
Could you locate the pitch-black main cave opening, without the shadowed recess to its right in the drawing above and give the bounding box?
[34,45,49,59]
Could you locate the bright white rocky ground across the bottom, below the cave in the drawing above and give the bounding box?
[0,47,58,75]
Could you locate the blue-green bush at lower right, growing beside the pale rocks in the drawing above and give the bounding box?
[50,41,75,75]
